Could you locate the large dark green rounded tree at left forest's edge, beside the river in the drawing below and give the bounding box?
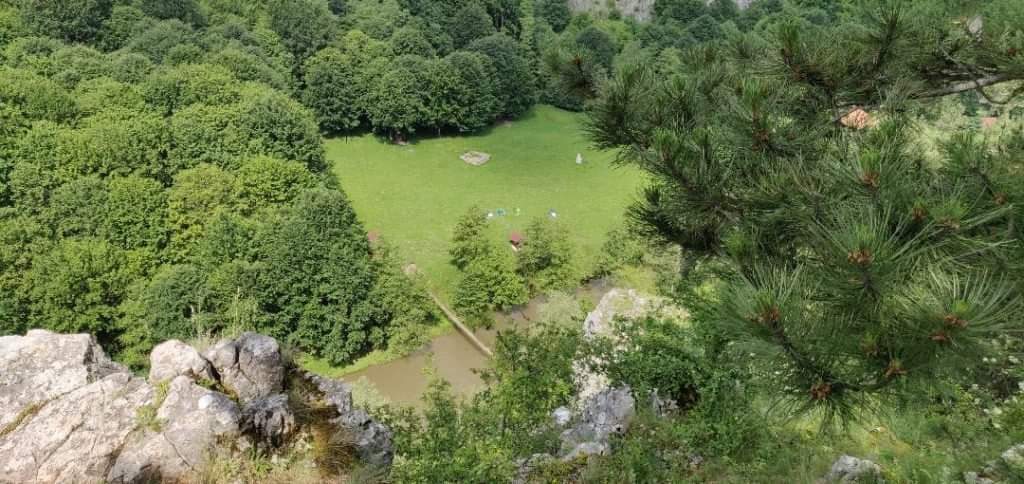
[256,188,387,364]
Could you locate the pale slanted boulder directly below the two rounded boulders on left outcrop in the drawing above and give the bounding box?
[106,376,242,483]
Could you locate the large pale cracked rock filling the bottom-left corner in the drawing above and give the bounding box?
[0,331,153,483]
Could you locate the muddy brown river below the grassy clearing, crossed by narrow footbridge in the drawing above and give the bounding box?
[342,279,611,406]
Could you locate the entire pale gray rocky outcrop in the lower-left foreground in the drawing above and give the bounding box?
[0,331,392,483]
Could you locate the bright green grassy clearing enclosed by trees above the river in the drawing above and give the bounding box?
[327,105,642,297]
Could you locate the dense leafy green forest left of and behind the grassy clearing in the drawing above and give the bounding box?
[0,0,798,363]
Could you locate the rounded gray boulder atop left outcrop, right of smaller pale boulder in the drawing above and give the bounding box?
[206,333,285,403]
